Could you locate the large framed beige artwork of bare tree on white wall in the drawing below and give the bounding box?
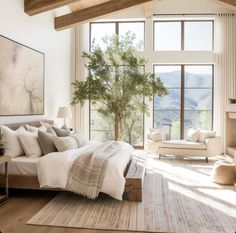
[0,35,44,116]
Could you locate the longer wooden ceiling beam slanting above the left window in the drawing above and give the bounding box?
[55,0,152,30]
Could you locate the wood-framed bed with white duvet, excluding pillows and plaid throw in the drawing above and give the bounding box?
[0,121,144,201]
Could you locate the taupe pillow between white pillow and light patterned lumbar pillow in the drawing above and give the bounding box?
[38,130,57,154]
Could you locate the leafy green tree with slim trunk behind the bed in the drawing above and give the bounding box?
[72,33,167,140]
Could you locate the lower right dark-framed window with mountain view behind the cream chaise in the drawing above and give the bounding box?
[154,65,213,139]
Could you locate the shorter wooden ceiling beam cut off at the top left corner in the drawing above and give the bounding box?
[24,0,78,15]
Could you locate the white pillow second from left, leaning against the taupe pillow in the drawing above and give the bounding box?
[19,131,43,158]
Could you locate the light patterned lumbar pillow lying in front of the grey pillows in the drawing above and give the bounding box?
[54,136,78,152]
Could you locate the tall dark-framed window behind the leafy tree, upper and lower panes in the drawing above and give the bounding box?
[90,21,144,147]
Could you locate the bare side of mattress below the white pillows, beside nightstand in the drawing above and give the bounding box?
[0,156,39,176]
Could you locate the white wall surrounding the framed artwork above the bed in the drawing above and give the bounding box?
[0,0,73,124]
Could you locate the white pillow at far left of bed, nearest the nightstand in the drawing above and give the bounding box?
[1,125,25,158]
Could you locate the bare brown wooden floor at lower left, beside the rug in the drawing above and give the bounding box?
[0,190,148,233]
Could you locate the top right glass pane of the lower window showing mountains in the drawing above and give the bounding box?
[185,66,212,88]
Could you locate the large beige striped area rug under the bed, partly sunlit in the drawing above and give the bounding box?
[28,158,236,233]
